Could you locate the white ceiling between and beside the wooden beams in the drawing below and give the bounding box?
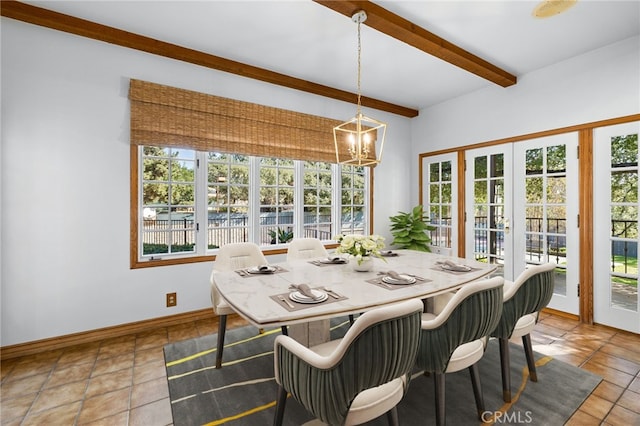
[22,0,640,113]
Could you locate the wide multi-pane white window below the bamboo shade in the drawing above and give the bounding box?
[132,146,370,266]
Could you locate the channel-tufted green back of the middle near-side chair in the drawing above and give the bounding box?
[416,277,504,373]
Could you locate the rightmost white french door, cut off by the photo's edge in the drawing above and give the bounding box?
[593,122,640,333]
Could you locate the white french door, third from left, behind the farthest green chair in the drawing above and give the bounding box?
[512,132,580,314]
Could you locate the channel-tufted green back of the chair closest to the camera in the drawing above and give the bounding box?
[274,299,423,425]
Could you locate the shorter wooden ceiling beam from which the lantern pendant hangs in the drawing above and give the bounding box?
[313,0,517,87]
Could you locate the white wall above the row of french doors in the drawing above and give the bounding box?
[411,37,640,201]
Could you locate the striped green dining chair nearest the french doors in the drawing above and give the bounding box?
[491,263,555,402]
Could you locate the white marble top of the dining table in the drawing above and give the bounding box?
[214,250,496,327]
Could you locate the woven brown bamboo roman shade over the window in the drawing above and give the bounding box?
[129,79,348,163]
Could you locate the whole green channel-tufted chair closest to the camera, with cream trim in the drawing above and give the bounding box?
[274,299,423,425]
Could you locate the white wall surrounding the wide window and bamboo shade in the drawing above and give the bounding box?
[0,18,411,346]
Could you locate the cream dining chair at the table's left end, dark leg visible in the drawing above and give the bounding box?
[209,242,267,368]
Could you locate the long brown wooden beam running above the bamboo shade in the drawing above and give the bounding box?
[0,0,418,117]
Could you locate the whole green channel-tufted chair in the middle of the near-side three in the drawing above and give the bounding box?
[416,277,504,425]
